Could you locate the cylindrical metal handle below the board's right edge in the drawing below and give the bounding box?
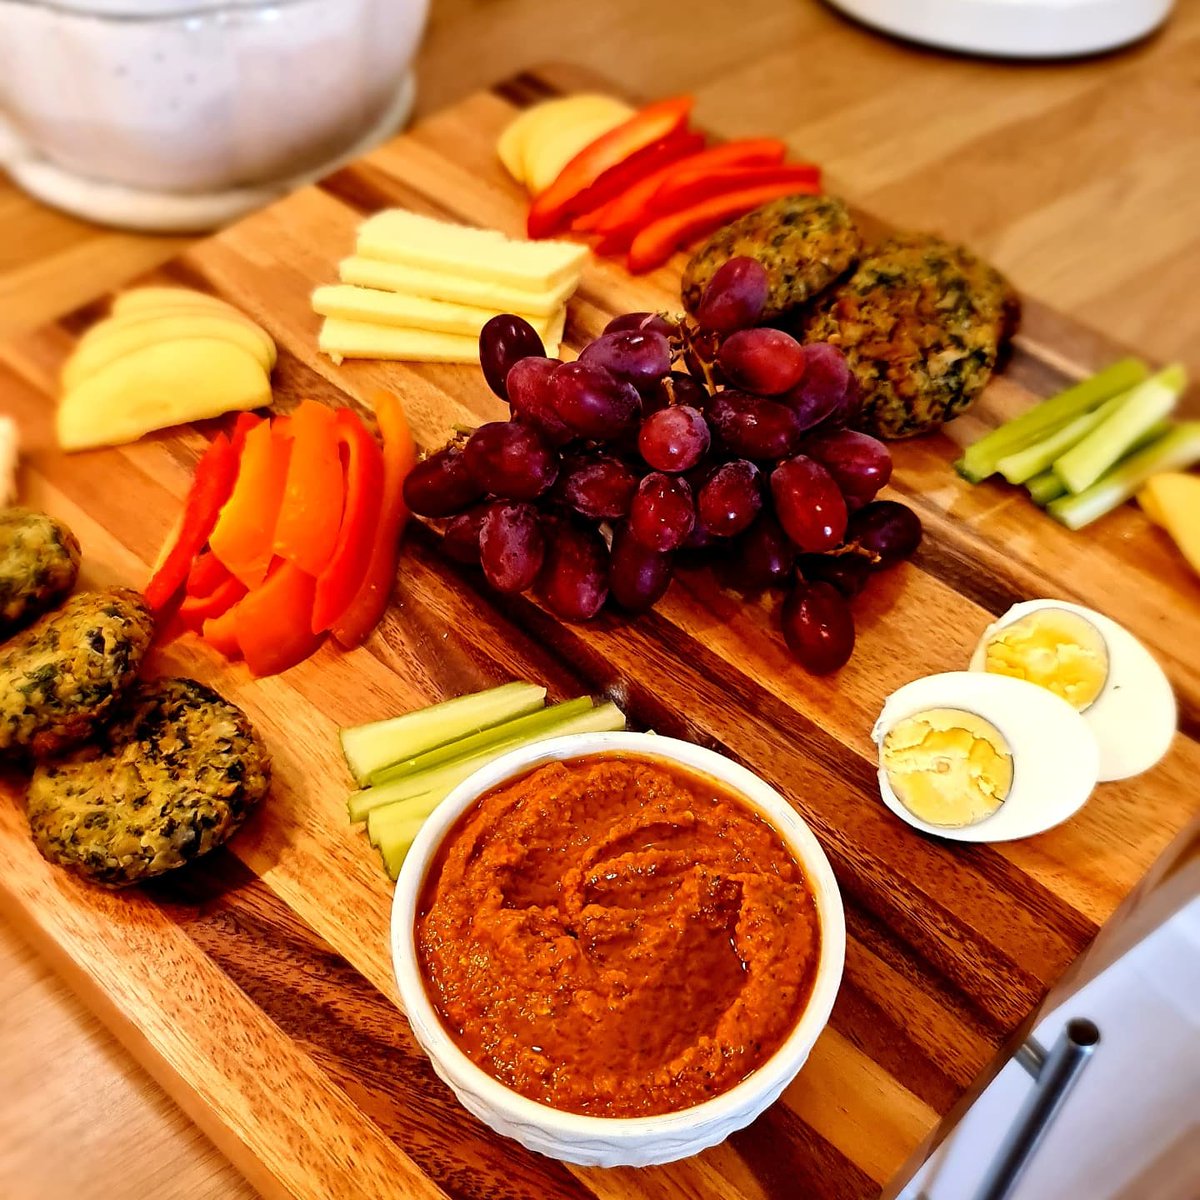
[976,1018,1100,1200]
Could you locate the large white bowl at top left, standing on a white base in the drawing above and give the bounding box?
[0,0,428,223]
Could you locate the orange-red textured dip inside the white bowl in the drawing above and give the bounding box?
[415,755,821,1117]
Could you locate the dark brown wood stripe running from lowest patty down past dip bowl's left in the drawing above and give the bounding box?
[149,851,594,1200]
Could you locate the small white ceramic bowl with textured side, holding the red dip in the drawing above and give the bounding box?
[391,733,846,1166]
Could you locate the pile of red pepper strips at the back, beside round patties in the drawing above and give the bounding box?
[528,96,821,274]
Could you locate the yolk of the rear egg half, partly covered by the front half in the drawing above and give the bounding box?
[984,608,1109,712]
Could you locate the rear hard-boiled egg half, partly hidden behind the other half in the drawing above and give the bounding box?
[971,600,1177,780]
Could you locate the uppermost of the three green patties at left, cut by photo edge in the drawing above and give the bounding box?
[0,508,79,637]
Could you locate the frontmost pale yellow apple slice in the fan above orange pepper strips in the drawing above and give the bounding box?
[56,337,271,450]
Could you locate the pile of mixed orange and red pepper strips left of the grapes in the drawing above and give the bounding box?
[146,392,416,676]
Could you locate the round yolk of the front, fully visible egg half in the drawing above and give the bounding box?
[880,708,1013,827]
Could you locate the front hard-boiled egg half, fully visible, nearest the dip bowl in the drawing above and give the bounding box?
[871,671,1099,841]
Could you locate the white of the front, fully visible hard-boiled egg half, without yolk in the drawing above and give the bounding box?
[871,671,1099,841]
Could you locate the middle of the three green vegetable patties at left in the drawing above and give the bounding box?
[0,588,154,758]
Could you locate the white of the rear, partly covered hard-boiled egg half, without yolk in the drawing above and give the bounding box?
[971,600,1178,782]
